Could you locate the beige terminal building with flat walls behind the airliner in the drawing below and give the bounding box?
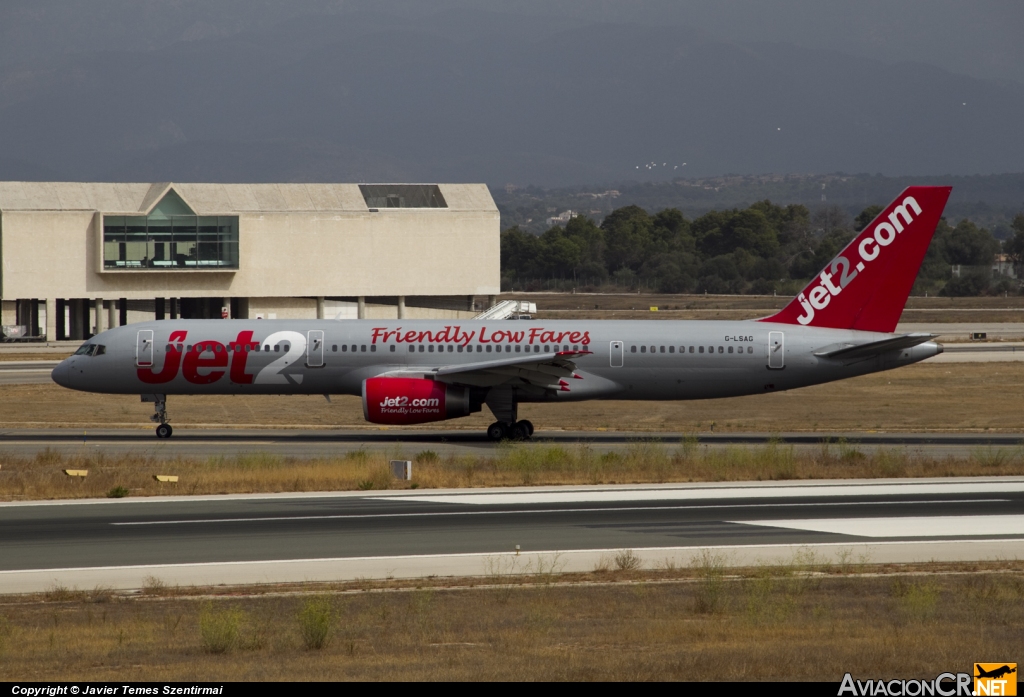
[0,181,501,341]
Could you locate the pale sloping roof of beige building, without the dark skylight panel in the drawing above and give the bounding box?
[0,181,498,215]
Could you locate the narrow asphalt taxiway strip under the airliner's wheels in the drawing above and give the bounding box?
[0,427,1024,459]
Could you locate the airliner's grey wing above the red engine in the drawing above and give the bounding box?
[382,351,593,392]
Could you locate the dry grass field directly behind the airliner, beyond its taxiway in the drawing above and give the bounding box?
[0,363,1024,433]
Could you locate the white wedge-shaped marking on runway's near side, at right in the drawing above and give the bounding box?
[727,516,1024,537]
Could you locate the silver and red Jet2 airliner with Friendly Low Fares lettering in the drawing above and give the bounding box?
[52,186,951,433]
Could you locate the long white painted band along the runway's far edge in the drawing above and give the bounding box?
[402,480,1024,506]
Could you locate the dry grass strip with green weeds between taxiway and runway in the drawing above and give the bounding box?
[0,439,1024,500]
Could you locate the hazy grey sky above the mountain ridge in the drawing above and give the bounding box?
[0,0,1024,82]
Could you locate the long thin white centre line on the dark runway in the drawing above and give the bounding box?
[111,498,1010,525]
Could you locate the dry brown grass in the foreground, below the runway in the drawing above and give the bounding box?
[0,558,1024,682]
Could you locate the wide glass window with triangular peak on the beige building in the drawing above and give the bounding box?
[103,191,239,271]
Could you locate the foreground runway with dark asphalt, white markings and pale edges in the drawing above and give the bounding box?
[0,477,1024,593]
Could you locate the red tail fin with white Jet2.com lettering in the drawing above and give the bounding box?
[761,186,952,332]
